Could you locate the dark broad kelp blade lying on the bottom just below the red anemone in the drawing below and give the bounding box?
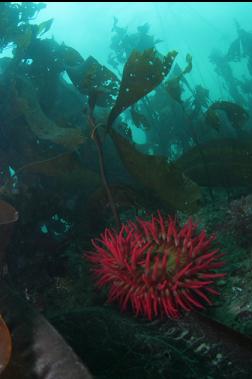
[52,306,252,379]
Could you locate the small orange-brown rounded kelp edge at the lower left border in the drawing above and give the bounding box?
[0,314,12,375]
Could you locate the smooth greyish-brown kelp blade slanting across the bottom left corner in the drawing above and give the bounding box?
[0,282,91,379]
